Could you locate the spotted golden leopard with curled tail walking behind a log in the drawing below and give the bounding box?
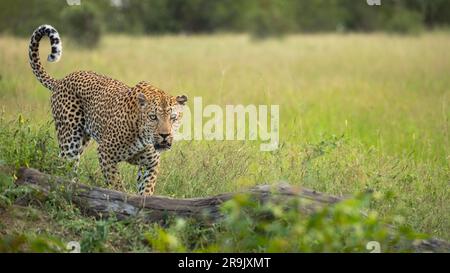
[29,25,188,196]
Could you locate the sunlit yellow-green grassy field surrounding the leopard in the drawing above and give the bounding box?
[0,32,450,250]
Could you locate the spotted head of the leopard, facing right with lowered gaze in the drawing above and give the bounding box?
[137,82,187,151]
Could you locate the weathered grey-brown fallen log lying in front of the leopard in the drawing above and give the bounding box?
[16,168,450,252]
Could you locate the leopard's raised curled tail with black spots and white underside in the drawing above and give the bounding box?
[29,25,62,91]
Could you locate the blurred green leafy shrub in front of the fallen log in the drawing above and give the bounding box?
[146,191,424,252]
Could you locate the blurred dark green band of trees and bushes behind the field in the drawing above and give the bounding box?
[0,0,450,46]
